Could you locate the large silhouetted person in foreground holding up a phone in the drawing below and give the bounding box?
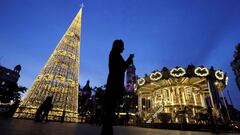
[101,40,134,135]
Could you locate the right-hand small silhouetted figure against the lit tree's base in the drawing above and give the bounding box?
[41,96,53,121]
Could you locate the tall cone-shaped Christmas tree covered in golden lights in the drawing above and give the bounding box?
[13,7,82,122]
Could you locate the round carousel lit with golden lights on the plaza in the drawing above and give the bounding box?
[135,65,228,124]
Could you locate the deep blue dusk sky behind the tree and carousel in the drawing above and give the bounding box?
[0,0,240,108]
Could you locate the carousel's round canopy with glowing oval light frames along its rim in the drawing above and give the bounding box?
[135,65,228,91]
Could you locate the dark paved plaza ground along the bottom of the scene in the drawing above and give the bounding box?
[0,119,237,135]
